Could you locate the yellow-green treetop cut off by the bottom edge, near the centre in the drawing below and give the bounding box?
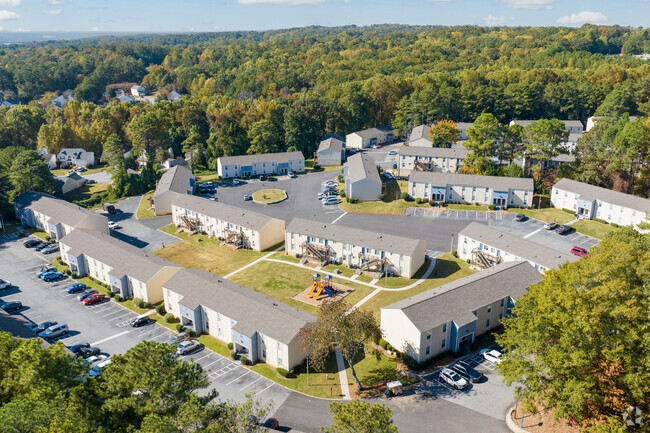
[320,400,398,433]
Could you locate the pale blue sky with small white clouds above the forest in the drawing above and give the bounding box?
[0,0,650,33]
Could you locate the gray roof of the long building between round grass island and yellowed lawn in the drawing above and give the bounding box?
[172,194,275,230]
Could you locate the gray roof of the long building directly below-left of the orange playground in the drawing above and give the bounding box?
[163,269,316,344]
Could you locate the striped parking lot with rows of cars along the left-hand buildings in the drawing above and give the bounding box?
[0,235,291,407]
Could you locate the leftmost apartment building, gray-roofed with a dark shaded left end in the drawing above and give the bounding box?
[14,191,108,240]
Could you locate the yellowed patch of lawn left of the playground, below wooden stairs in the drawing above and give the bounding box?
[153,224,266,276]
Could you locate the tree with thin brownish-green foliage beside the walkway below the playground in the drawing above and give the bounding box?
[300,300,382,390]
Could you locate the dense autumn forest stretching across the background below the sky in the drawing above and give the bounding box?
[0,25,650,204]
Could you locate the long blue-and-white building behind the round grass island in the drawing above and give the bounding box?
[217,152,305,179]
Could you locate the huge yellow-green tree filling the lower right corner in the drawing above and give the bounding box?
[497,228,650,425]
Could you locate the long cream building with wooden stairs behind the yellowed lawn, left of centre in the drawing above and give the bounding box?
[172,195,284,251]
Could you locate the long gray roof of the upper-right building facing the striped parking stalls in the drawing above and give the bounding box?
[409,171,533,191]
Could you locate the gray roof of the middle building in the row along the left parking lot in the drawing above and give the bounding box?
[60,229,180,282]
